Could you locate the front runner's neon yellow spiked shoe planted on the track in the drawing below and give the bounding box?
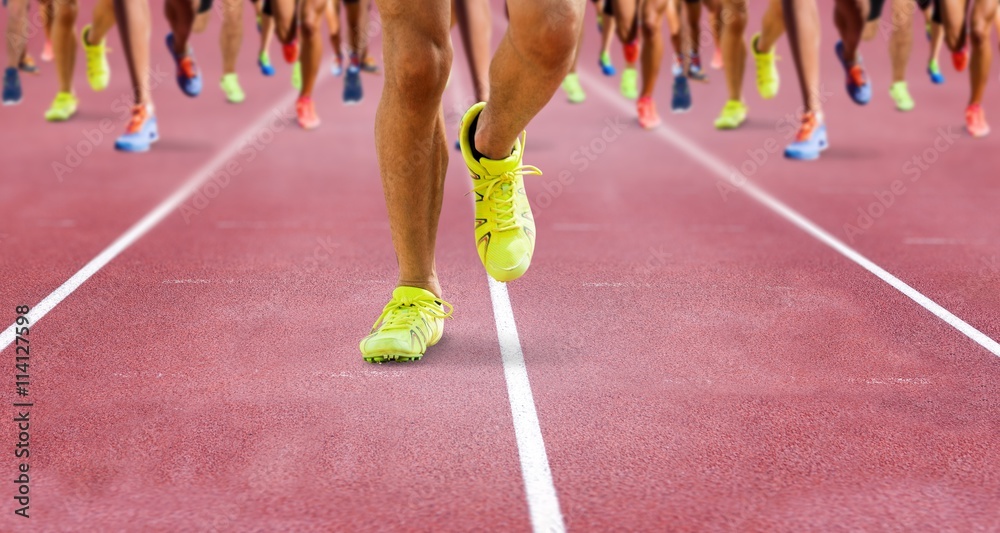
[360,287,452,363]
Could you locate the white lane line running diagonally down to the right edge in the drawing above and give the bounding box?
[579,71,1000,356]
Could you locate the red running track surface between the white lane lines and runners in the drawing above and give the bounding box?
[0,2,1000,531]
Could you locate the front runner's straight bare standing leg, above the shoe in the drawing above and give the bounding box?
[375,0,452,296]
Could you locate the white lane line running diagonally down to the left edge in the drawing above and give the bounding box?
[0,86,306,351]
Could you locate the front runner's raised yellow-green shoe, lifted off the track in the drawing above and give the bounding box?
[458,102,542,281]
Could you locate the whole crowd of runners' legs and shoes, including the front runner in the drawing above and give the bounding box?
[3,0,1000,362]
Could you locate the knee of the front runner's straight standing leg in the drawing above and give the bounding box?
[385,38,452,107]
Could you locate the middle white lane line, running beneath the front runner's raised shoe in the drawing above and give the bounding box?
[447,71,566,533]
